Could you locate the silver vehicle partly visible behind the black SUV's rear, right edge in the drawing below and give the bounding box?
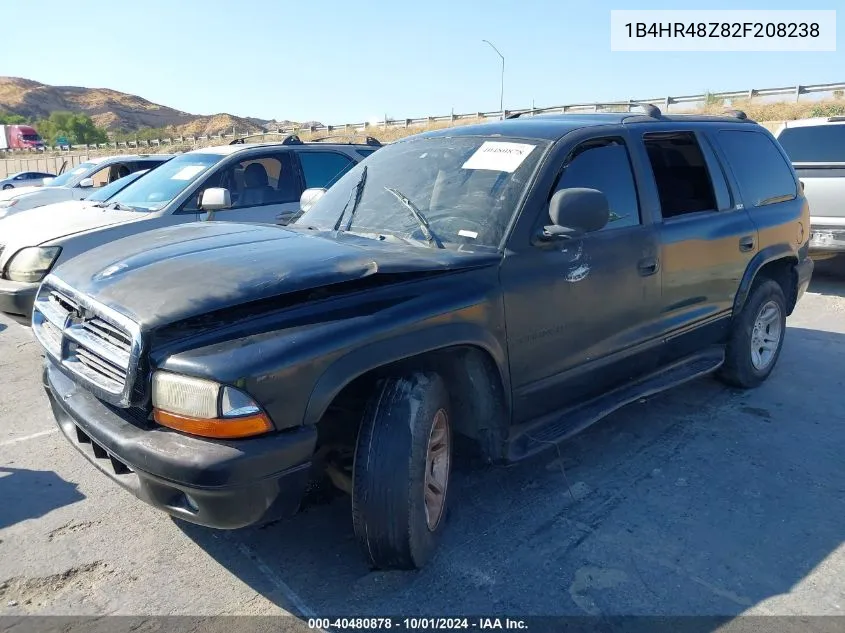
[775,116,845,252]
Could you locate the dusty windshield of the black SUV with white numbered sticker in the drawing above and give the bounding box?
[293,136,549,250]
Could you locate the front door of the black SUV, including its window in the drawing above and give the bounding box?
[501,137,661,424]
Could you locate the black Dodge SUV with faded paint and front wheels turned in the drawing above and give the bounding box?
[33,108,813,568]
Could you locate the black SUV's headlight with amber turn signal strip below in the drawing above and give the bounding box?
[153,371,273,439]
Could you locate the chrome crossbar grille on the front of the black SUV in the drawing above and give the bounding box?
[32,276,141,407]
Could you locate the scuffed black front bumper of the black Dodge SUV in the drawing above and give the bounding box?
[43,361,316,529]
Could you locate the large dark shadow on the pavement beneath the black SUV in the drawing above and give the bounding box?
[179,327,845,617]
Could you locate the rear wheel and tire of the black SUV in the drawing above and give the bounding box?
[718,279,786,389]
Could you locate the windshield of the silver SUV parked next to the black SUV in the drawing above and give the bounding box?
[109,152,224,211]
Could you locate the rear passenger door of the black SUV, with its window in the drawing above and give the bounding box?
[642,130,758,363]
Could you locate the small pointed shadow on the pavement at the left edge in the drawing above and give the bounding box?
[0,466,85,529]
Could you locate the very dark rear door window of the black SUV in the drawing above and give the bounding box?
[643,132,721,220]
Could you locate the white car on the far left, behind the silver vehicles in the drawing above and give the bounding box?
[0,154,173,218]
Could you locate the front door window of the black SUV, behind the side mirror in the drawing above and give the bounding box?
[555,139,640,230]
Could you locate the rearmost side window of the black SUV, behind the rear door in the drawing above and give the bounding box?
[718,130,798,207]
